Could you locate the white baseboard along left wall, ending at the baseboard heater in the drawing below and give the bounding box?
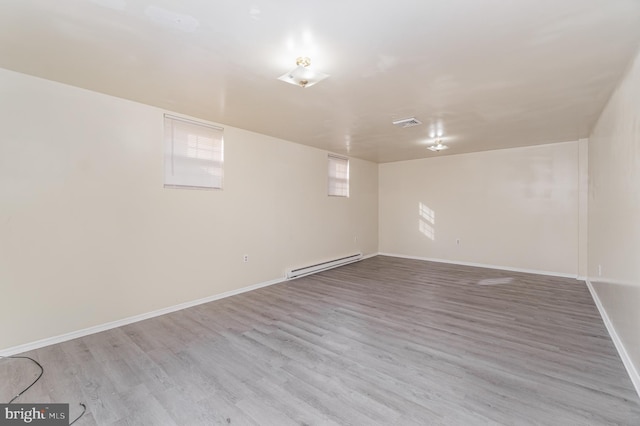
[0,277,286,356]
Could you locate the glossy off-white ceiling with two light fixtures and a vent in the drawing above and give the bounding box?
[0,0,640,162]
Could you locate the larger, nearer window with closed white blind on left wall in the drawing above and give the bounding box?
[164,115,224,189]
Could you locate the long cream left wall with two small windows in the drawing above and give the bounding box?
[0,70,378,350]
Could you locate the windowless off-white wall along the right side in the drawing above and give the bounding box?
[588,46,640,382]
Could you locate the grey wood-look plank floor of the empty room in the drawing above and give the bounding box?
[0,256,640,426]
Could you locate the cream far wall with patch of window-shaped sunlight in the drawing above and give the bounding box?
[379,141,579,276]
